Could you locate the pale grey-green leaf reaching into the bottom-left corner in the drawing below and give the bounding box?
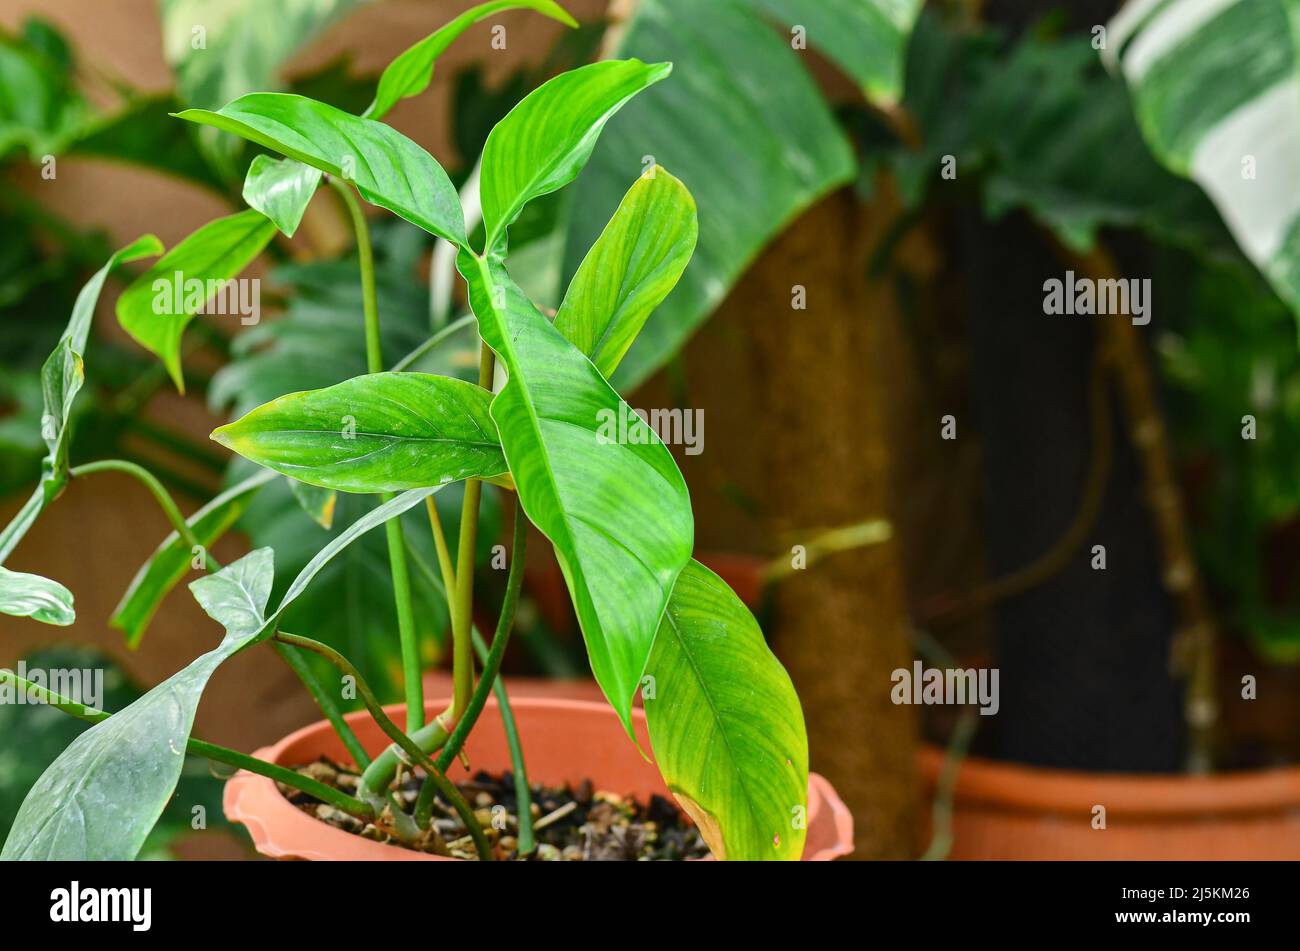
[0,548,273,861]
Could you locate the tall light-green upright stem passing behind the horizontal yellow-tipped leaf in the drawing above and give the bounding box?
[329,175,424,733]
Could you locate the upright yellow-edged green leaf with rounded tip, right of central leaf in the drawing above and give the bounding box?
[555,168,699,378]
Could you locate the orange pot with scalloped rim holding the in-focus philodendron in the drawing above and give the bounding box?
[224,696,853,861]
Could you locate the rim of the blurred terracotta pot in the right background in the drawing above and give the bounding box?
[917,743,1300,818]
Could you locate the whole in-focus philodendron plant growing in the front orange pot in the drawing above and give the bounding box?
[0,0,807,860]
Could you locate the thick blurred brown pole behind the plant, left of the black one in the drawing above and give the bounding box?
[719,192,918,859]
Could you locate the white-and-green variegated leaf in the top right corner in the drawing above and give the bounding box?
[1104,0,1300,312]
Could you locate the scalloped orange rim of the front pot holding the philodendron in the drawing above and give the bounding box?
[222,696,853,861]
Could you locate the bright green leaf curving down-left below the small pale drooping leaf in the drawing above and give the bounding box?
[117,209,276,392]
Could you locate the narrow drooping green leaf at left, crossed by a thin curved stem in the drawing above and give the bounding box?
[109,472,276,650]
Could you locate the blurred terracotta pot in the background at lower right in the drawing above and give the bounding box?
[919,746,1300,860]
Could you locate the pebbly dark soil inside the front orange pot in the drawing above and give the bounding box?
[277,759,709,861]
